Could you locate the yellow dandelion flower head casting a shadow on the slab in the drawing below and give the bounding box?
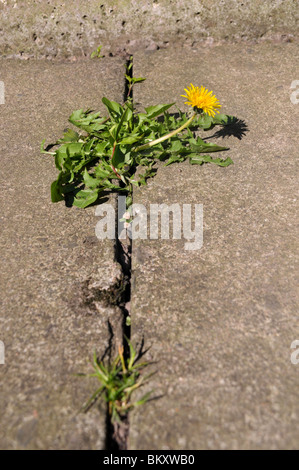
[181,83,221,117]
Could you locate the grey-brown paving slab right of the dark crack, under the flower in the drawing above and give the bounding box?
[130,44,299,449]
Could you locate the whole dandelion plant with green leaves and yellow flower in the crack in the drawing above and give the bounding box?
[41,77,234,208]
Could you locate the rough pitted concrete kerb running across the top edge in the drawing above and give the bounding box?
[0,0,299,58]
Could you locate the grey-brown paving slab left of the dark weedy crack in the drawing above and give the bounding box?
[0,59,123,449]
